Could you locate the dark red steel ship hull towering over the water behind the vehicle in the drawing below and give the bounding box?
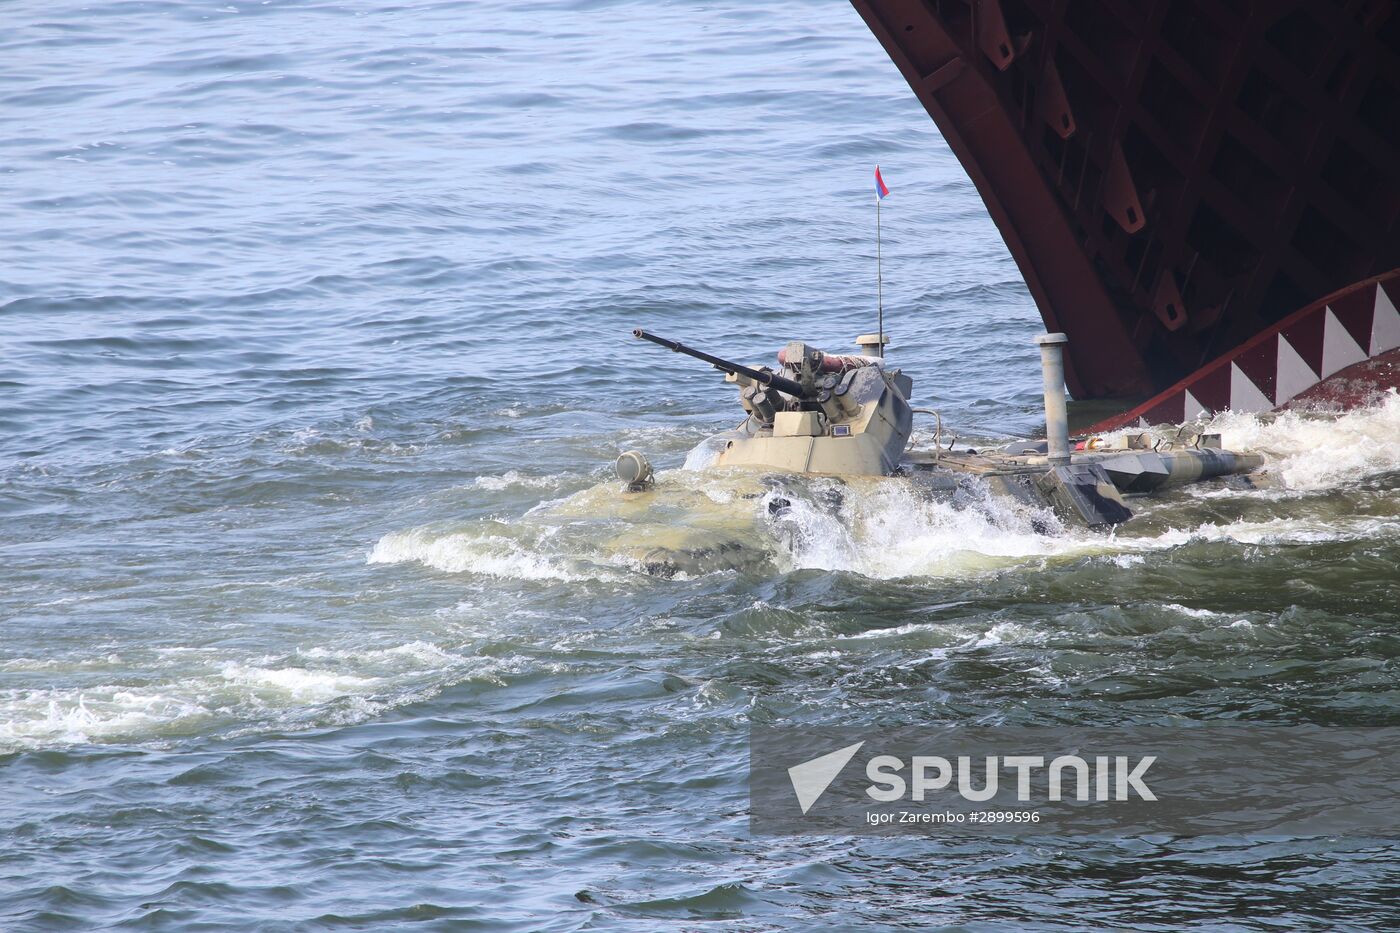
[851,0,1400,420]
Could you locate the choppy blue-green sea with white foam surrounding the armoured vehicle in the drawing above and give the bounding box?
[0,0,1400,930]
